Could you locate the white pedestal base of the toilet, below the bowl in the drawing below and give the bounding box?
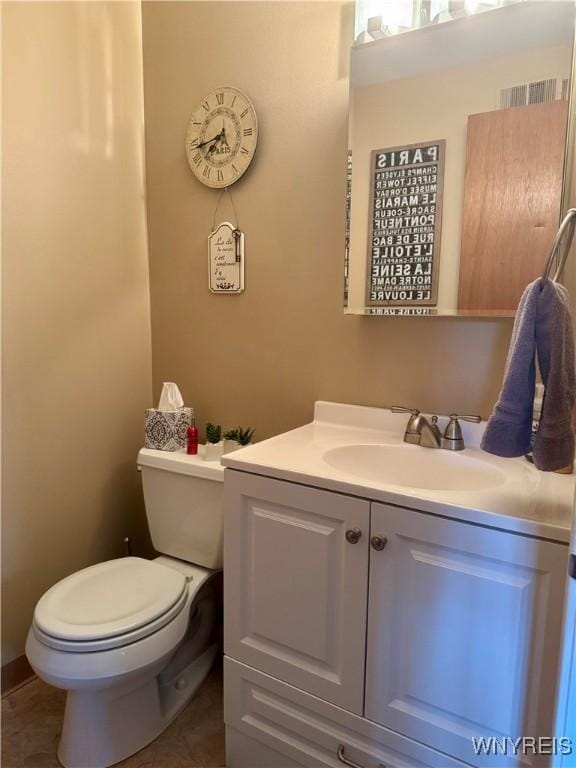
[58,643,219,768]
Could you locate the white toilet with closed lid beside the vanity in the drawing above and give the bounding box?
[26,448,224,768]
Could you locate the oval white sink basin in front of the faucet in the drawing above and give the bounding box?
[323,444,507,491]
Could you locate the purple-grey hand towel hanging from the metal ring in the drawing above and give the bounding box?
[482,278,576,470]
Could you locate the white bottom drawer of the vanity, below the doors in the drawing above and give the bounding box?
[224,658,464,768]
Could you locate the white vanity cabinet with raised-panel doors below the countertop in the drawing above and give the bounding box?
[224,469,568,768]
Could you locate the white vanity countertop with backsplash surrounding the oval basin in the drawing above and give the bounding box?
[222,401,575,543]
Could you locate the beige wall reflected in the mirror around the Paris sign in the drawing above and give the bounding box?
[349,45,572,311]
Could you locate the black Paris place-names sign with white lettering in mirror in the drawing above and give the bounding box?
[366,139,446,306]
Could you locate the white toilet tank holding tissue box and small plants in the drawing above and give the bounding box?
[138,446,224,568]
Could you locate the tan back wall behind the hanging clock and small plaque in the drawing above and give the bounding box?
[143,2,511,438]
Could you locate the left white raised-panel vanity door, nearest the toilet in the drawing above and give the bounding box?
[224,470,370,713]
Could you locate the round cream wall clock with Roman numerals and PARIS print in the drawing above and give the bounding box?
[186,86,258,188]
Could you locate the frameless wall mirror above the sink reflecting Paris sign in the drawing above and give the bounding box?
[344,0,575,317]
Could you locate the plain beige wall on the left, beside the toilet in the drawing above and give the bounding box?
[2,2,151,663]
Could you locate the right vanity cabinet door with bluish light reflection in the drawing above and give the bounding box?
[366,504,567,768]
